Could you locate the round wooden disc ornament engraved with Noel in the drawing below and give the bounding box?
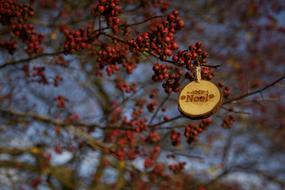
[178,80,222,119]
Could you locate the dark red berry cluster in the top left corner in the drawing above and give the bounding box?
[0,0,35,25]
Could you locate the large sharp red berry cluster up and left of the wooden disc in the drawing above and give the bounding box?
[130,10,184,60]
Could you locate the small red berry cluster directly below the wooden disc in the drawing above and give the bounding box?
[184,118,212,144]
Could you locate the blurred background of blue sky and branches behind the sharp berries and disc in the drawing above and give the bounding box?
[0,0,285,190]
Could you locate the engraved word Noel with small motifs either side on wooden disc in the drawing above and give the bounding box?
[181,90,215,103]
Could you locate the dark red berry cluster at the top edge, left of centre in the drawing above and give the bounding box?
[93,0,122,32]
